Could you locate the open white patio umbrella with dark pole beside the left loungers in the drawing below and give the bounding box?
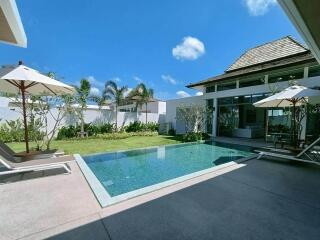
[0,61,75,153]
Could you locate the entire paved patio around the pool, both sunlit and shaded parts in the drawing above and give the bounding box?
[0,155,320,240]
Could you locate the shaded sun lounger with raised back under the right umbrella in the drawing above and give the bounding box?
[257,138,320,165]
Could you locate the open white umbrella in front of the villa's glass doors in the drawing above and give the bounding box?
[253,85,320,146]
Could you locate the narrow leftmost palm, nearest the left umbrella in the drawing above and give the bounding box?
[75,78,91,138]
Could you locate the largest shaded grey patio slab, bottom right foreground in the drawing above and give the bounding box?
[103,161,320,239]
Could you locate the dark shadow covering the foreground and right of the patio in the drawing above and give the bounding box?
[47,160,320,240]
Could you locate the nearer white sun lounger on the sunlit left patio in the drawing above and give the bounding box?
[0,156,74,175]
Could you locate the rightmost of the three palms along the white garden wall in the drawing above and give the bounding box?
[129,83,153,123]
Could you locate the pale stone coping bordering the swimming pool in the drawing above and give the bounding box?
[74,143,257,208]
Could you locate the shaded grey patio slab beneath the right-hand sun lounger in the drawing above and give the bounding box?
[225,159,320,209]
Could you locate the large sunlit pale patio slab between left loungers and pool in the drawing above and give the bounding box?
[0,162,100,239]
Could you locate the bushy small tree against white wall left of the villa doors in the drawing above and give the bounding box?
[176,104,209,133]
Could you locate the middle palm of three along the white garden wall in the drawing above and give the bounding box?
[102,81,128,130]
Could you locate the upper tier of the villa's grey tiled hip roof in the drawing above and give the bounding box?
[226,36,309,72]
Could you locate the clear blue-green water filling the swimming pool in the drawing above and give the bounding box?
[83,142,253,197]
